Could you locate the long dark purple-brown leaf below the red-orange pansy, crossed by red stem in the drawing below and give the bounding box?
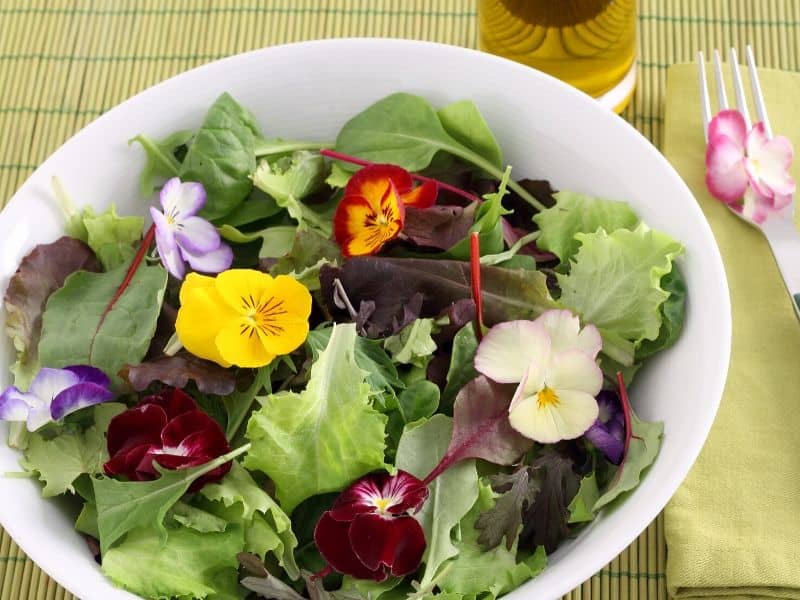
[320,256,556,332]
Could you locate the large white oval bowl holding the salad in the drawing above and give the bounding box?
[0,39,731,600]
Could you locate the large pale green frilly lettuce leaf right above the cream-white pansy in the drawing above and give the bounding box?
[557,224,683,366]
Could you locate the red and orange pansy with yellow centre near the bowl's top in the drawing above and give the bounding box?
[333,164,437,257]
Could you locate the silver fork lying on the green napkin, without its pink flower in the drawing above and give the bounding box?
[697,46,800,319]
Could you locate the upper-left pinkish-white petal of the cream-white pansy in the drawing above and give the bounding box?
[475,321,550,383]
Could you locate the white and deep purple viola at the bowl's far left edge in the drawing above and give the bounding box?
[0,365,114,431]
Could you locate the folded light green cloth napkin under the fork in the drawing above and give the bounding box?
[664,64,800,599]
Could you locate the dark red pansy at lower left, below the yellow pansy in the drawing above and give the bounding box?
[103,388,231,492]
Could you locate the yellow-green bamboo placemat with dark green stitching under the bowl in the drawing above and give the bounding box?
[0,0,800,600]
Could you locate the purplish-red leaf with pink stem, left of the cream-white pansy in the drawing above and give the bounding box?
[425,375,533,482]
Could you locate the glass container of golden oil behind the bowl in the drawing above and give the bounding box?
[478,0,636,111]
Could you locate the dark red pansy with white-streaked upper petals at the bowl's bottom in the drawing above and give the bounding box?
[314,471,428,581]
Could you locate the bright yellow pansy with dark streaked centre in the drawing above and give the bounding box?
[175,269,311,368]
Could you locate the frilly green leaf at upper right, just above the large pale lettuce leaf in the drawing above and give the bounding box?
[533,191,639,264]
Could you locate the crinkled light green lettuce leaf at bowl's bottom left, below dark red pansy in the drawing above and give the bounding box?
[102,525,244,600]
